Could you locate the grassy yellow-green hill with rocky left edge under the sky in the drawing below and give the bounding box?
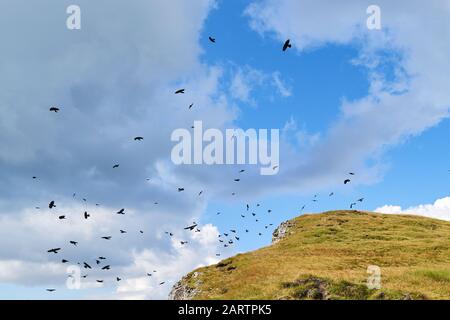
[171,211,450,299]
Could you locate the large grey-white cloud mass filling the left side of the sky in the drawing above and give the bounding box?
[0,0,235,298]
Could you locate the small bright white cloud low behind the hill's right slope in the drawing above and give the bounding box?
[375,197,450,221]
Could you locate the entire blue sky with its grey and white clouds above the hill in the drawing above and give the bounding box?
[0,0,450,299]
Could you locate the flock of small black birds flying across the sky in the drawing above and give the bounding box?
[39,37,364,292]
